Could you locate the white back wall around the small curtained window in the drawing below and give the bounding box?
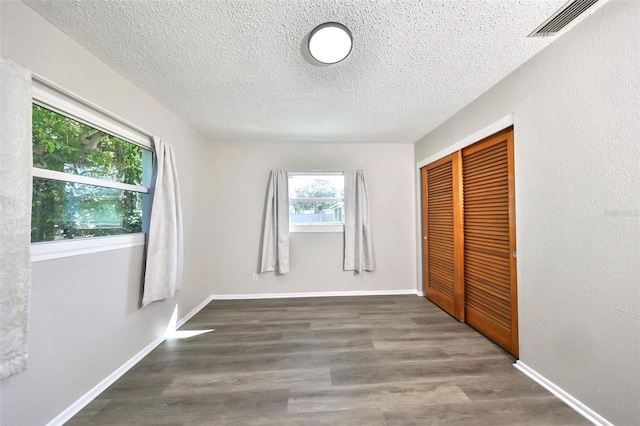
[211,143,416,295]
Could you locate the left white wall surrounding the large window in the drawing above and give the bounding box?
[0,1,212,425]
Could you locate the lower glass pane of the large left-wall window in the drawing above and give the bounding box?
[31,178,147,243]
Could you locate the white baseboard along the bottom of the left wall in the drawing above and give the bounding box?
[47,296,213,426]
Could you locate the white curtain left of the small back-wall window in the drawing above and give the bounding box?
[260,170,289,274]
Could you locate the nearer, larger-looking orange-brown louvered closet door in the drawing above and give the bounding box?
[462,129,518,356]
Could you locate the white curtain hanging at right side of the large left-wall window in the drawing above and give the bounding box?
[142,137,184,306]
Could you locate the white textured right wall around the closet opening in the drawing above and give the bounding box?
[415,1,640,425]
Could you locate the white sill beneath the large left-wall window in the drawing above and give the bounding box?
[31,233,145,263]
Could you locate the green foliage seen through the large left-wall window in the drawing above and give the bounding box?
[31,104,152,243]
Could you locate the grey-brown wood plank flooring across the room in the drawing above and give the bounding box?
[68,296,590,426]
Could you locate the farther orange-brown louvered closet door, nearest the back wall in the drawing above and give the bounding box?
[421,152,464,321]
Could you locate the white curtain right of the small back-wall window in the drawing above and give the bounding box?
[344,170,376,273]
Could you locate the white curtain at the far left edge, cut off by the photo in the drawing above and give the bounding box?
[0,59,33,379]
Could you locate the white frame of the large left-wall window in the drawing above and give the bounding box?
[31,76,155,262]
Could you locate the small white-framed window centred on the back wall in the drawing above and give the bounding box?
[289,173,344,232]
